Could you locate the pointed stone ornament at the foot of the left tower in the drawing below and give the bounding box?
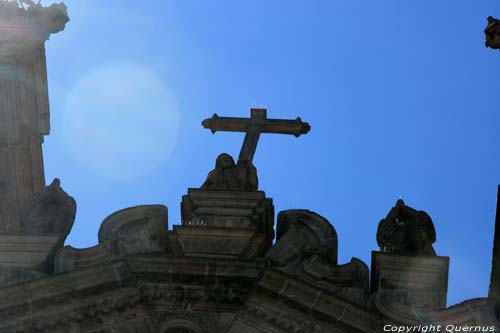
[22,178,76,235]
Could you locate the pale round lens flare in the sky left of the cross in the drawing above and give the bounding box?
[62,63,180,179]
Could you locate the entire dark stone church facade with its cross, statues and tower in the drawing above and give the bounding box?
[0,1,500,333]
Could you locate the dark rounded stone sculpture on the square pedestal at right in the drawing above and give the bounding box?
[377,199,436,256]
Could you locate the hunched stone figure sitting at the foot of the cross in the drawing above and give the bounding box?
[201,153,258,191]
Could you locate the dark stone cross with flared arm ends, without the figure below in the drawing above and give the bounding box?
[201,109,311,162]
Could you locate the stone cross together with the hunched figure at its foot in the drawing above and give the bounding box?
[201,109,311,191]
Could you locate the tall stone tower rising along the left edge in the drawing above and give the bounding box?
[0,1,68,234]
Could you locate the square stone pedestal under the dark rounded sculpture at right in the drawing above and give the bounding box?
[371,251,450,308]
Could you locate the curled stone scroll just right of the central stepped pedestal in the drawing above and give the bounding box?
[266,209,368,303]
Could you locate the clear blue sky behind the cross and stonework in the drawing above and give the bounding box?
[40,0,500,305]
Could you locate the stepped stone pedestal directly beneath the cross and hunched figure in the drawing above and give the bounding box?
[169,189,274,259]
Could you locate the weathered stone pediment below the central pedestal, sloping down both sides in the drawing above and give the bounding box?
[0,255,375,333]
